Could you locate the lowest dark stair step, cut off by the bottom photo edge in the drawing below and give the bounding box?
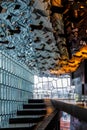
[0,125,36,130]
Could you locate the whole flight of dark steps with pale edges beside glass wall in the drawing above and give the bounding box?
[0,99,46,130]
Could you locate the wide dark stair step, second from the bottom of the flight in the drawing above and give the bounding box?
[9,116,44,124]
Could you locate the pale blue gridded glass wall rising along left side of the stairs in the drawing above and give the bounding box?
[0,51,34,127]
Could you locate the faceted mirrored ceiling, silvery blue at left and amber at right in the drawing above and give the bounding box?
[0,0,87,75]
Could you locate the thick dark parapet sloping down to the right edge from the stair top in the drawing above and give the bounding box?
[52,99,87,122]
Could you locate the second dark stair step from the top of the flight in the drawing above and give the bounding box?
[23,103,46,109]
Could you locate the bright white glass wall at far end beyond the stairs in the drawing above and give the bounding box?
[34,75,74,99]
